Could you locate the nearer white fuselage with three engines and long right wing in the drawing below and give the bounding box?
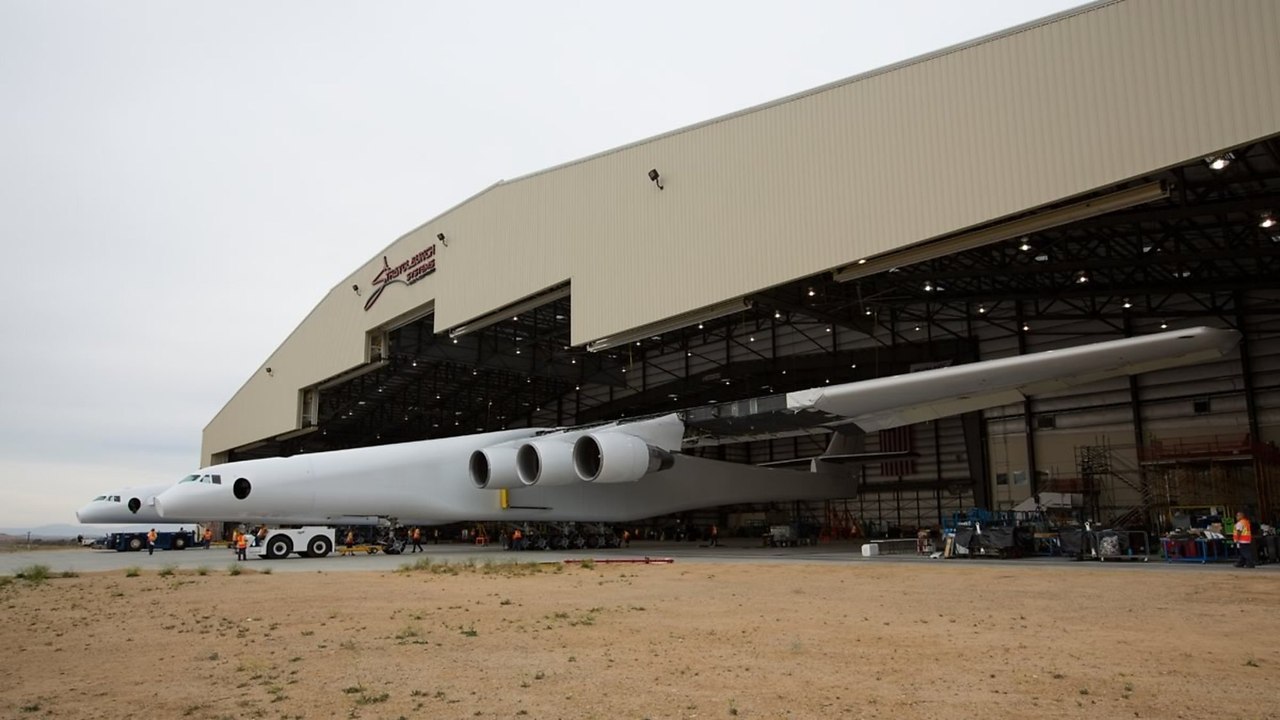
[156,328,1239,524]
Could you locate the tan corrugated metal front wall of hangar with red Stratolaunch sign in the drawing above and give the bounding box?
[205,0,1280,460]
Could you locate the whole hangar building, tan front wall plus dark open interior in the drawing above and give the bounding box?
[202,0,1280,527]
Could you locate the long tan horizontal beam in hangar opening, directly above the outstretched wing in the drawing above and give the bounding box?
[832,182,1169,282]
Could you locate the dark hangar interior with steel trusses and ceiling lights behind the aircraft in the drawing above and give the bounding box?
[214,3,1280,536]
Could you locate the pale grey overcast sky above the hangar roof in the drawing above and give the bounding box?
[0,0,1082,528]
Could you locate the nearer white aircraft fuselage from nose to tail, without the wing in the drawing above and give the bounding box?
[156,416,852,524]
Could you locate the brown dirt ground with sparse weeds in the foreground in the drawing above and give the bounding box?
[0,561,1280,720]
